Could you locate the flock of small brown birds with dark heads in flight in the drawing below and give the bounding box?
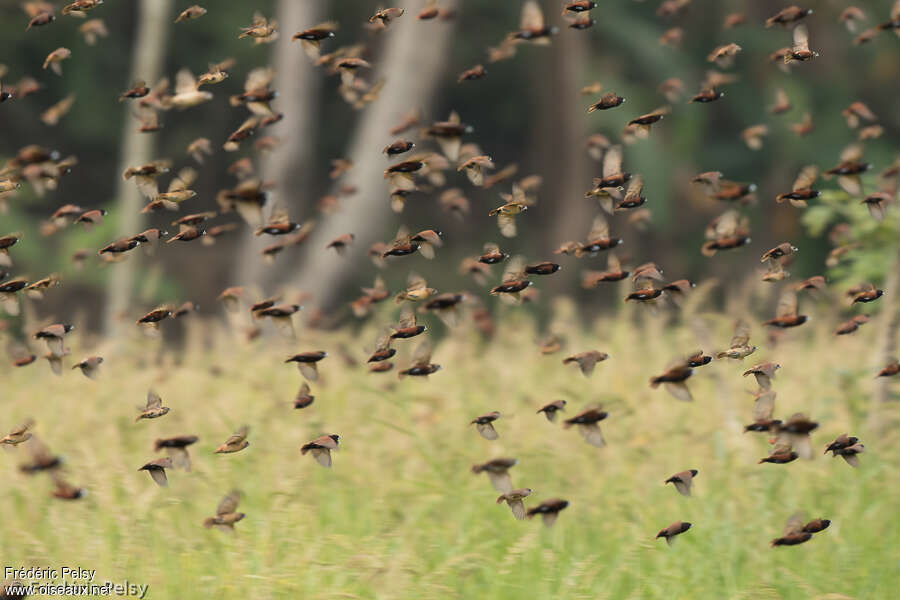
[0,0,900,588]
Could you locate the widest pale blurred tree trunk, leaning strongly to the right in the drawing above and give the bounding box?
[284,1,455,308]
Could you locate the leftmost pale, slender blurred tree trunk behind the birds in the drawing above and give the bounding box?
[104,0,172,339]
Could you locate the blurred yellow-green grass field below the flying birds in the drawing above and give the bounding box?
[0,300,900,599]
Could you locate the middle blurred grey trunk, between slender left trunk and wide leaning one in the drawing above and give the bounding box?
[235,0,325,285]
